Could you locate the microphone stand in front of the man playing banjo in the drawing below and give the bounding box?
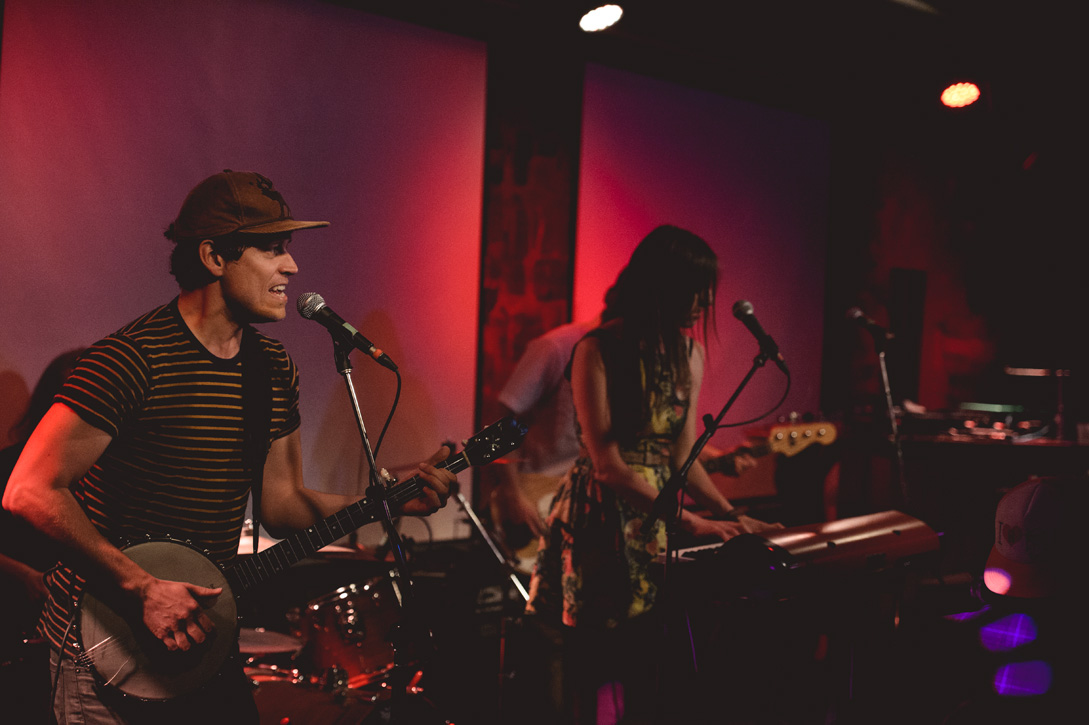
[333,337,413,709]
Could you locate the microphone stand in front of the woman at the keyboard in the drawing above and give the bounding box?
[645,347,770,720]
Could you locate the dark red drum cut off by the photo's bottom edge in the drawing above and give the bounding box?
[246,666,380,725]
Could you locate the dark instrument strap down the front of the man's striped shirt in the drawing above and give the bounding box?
[241,325,272,554]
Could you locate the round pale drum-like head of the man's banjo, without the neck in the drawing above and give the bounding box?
[78,541,237,700]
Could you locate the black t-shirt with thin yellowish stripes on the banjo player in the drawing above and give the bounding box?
[39,299,299,656]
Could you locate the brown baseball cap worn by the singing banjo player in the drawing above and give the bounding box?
[172,169,329,239]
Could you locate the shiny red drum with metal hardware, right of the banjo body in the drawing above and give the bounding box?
[298,577,409,688]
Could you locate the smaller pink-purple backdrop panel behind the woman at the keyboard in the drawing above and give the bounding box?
[575,65,829,445]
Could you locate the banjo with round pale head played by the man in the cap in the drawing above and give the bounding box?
[76,416,526,700]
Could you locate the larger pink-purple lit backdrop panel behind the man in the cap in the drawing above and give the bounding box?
[0,0,485,538]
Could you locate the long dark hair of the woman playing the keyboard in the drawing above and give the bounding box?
[602,225,719,440]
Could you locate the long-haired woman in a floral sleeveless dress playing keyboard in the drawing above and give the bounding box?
[527,226,769,723]
